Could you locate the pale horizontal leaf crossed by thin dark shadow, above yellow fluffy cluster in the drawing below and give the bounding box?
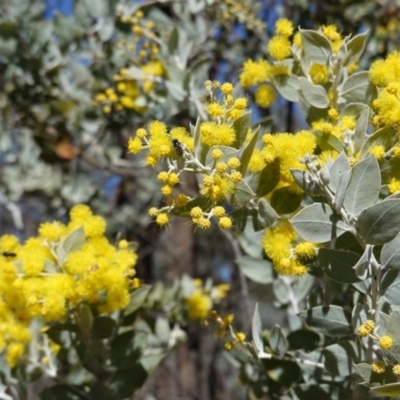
[290,203,347,243]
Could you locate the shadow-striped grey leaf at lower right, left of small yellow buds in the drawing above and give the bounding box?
[299,305,353,336]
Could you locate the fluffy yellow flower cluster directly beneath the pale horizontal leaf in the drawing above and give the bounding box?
[262,219,318,275]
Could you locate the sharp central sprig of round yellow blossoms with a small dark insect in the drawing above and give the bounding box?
[128,81,251,229]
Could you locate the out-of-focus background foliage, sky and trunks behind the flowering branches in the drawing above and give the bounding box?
[0,0,400,400]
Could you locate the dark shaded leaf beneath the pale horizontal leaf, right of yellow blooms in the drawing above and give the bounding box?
[318,248,360,283]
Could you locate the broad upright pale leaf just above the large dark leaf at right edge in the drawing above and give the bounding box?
[344,156,381,216]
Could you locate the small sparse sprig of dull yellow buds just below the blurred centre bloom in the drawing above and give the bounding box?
[203,310,246,351]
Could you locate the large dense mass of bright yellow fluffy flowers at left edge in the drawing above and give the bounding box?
[0,205,140,367]
